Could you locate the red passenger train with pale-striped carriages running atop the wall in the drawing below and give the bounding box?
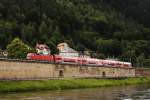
[26,53,132,68]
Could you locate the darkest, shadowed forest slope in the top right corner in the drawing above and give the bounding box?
[103,0,150,26]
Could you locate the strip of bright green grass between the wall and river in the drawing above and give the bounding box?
[0,78,150,92]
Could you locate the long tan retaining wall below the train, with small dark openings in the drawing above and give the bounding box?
[0,60,135,79]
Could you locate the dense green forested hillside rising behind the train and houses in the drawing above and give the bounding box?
[0,0,150,66]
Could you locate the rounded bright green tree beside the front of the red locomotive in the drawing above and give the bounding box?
[6,38,34,59]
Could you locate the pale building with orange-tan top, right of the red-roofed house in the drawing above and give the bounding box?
[57,43,79,57]
